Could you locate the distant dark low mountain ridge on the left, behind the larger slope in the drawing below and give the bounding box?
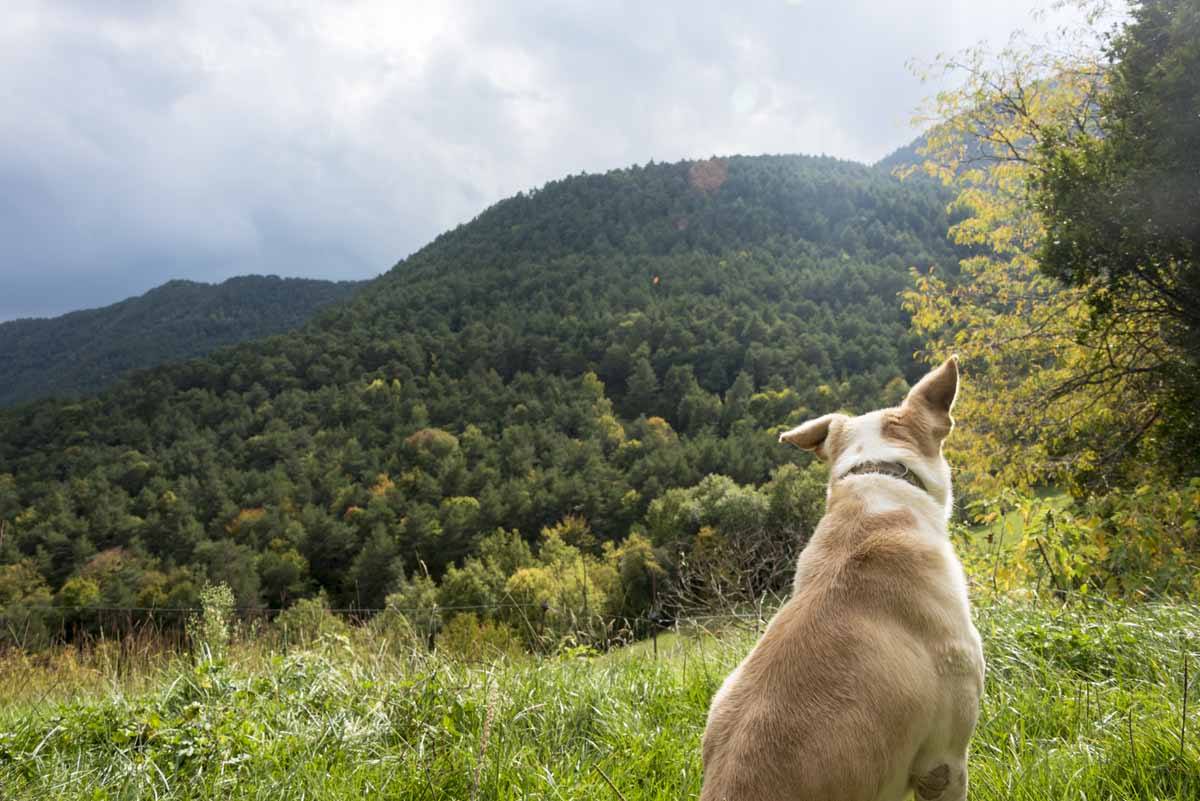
[0,276,359,405]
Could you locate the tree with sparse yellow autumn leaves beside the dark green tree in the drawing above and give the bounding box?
[904,4,1158,496]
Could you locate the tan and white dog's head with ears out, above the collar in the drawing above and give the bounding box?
[779,356,959,517]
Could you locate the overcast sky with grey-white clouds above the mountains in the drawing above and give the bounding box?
[0,0,1089,320]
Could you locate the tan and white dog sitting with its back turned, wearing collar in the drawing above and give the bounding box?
[700,359,983,801]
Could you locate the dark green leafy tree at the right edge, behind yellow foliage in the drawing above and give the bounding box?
[1034,0,1200,472]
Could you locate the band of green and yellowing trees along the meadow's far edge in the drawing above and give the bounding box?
[0,464,826,651]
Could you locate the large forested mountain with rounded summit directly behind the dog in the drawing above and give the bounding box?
[0,156,956,607]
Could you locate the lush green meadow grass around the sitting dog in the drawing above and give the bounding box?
[0,600,1200,801]
